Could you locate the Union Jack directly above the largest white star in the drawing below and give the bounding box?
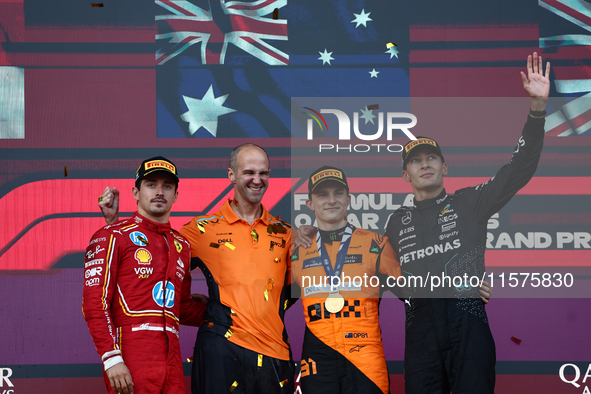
[156,0,289,66]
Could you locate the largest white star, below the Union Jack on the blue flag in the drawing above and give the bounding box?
[181,85,236,137]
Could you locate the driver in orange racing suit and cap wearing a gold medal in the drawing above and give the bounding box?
[292,166,401,394]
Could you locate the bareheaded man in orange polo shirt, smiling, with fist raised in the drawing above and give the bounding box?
[99,144,295,394]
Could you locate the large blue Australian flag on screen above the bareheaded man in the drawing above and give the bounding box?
[155,0,409,138]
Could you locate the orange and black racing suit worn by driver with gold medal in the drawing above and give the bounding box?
[292,225,401,394]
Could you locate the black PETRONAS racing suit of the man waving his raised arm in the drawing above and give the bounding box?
[386,112,544,394]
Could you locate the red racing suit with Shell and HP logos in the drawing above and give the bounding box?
[82,212,205,394]
